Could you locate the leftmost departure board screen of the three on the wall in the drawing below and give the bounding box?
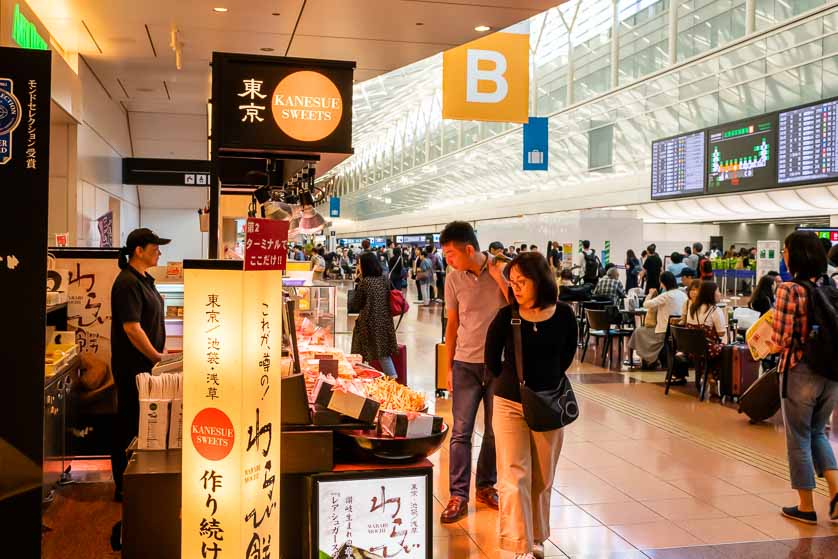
[652,130,706,200]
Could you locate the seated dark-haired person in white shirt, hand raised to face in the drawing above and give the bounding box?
[629,272,687,368]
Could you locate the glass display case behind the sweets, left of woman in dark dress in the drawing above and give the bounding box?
[282,278,337,349]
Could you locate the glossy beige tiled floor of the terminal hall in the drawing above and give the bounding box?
[362,286,838,559]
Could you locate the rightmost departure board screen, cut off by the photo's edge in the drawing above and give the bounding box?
[777,100,838,184]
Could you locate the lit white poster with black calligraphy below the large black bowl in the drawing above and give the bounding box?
[317,476,431,559]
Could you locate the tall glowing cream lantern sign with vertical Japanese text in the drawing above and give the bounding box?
[181,260,282,559]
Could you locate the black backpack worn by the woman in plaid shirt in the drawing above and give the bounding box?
[795,281,838,382]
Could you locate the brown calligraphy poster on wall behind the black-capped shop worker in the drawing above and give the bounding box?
[55,251,119,363]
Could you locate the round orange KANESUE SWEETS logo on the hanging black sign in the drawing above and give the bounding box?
[271,70,343,142]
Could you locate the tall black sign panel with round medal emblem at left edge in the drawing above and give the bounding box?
[0,47,51,557]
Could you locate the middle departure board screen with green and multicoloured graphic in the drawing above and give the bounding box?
[707,114,777,194]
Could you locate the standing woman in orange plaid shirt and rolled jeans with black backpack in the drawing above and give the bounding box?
[773,231,838,524]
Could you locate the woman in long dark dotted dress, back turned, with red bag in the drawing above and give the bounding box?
[350,252,399,378]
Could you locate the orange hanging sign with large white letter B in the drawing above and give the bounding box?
[442,33,530,122]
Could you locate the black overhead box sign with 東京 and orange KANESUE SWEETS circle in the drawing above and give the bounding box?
[212,52,355,153]
